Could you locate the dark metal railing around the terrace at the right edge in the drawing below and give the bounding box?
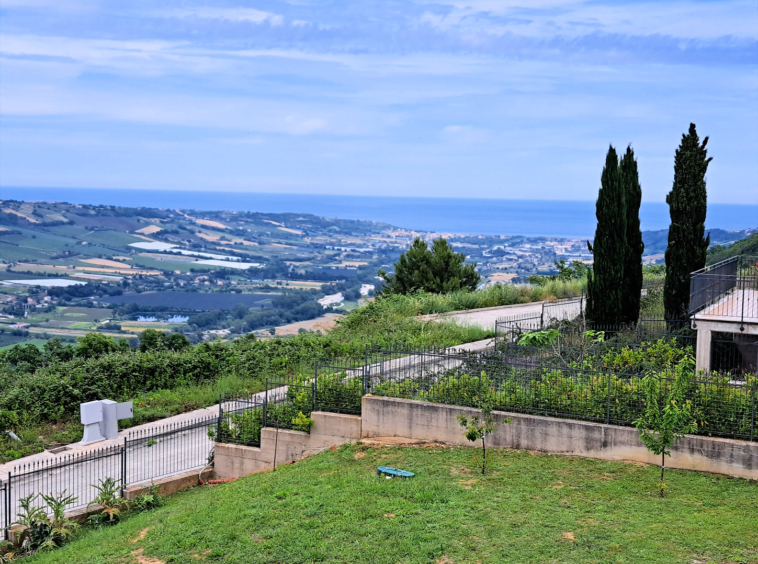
[689,255,758,328]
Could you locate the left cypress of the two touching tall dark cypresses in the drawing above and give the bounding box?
[587,146,627,324]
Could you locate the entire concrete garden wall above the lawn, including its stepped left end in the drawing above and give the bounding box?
[215,395,758,479]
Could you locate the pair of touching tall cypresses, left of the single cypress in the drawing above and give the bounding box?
[587,146,645,324]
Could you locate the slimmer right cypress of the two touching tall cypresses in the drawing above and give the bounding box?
[619,145,645,323]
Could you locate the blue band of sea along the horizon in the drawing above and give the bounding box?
[0,187,758,238]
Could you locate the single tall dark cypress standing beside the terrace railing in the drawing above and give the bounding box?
[663,123,713,319]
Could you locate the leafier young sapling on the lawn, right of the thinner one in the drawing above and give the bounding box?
[634,372,697,497]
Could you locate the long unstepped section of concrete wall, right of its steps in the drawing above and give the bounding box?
[361,395,758,479]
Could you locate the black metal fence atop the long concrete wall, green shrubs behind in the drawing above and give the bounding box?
[310,346,758,441]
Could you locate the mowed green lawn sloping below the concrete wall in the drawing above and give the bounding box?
[29,445,758,564]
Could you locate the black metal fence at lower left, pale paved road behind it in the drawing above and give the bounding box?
[0,416,218,538]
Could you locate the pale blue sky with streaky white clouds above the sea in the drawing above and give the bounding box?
[0,0,758,204]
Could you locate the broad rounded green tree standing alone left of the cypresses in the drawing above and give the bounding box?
[379,237,481,296]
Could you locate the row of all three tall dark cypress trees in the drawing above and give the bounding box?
[587,123,712,324]
